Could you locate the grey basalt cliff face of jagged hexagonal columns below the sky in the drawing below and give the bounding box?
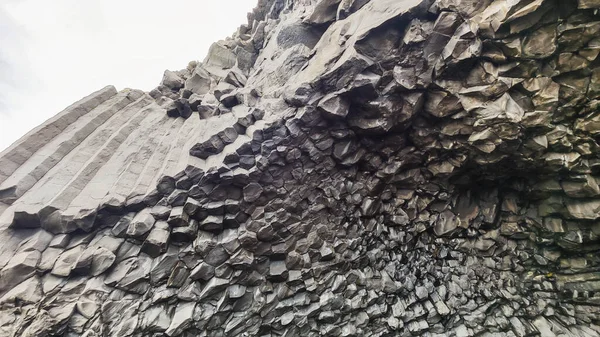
[0,0,600,337]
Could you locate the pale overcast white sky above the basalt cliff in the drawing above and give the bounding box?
[0,0,256,151]
